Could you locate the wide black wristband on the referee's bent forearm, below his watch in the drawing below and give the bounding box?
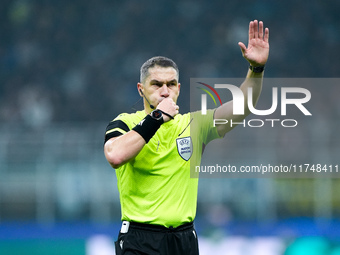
[132,115,164,143]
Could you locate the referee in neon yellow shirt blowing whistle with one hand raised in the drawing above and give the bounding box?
[104,20,269,255]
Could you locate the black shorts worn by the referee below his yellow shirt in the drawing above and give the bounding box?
[115,222,199,255]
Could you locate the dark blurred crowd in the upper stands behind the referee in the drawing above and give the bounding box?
[0,0,340,128]
